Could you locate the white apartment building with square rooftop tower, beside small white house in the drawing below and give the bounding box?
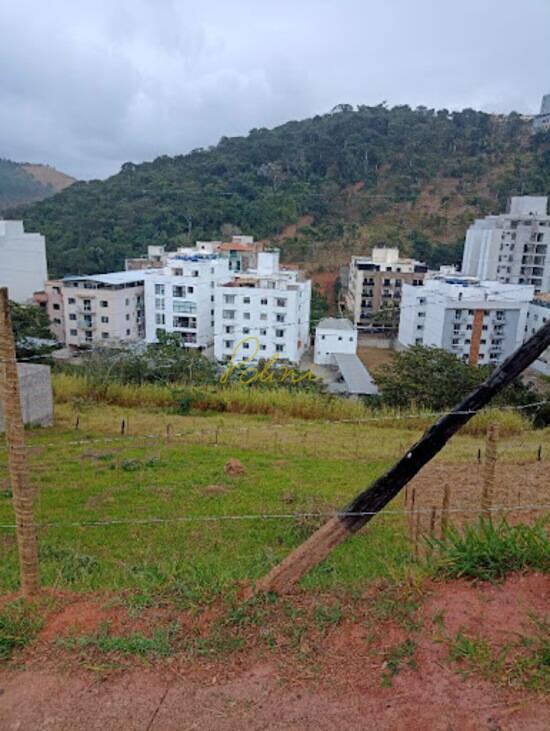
[214,251,311,363]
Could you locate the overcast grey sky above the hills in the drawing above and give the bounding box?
[0,0,550,178]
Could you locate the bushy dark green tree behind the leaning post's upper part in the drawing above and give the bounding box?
[375,345,540,411]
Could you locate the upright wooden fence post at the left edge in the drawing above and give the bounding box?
[0,287,40,596]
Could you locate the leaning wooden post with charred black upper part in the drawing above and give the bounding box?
[256,320,550,593]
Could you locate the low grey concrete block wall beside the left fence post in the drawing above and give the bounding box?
[0,363,53,432]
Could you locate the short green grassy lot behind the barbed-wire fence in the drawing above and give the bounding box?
[0,404,550,604]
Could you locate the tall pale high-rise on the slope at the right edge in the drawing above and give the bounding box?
[462,196,550,293]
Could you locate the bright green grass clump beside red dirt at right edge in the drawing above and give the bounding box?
[430,519,550,581]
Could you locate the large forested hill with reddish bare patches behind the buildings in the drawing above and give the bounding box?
[10,105,550,275]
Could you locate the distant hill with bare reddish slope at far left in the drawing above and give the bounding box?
[0,158,74,211]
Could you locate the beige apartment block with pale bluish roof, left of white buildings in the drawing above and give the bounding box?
[61,271,147,347]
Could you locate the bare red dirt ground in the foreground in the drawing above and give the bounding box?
[0,574,550,731]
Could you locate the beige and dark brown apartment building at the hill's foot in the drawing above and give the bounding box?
[346,248,428,329]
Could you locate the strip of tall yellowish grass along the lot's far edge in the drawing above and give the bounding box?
[53,373,531,437]
